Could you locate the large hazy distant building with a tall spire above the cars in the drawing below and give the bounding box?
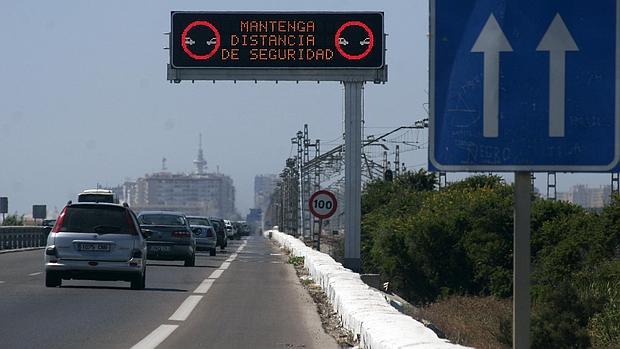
[122,139,237,218]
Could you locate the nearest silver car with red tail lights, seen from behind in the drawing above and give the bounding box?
[44,202,146,290]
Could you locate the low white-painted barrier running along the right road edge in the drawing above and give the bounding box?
[264,230,466,349]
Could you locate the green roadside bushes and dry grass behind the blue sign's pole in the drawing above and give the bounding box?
[362,170,620,348]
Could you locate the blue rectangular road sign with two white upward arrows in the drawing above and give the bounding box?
[429,0,620,172]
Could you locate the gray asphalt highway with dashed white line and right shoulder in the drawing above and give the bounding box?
[0,236,338,349]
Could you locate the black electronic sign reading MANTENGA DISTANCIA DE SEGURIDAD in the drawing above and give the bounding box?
[170,12,385,69]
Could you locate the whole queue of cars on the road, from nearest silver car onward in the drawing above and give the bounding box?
[44,189,249,290]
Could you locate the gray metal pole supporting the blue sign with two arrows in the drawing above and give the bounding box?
[512,172,531,349]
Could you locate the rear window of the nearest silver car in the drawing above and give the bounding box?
[59,206,135,234]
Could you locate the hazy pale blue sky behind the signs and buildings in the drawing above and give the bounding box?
[0,0,609,215]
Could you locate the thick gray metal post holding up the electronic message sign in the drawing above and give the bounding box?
[344,81,364,272]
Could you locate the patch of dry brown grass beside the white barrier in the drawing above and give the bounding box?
[410,296,512,349]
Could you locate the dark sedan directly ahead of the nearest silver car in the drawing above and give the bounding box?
[138,211,196,267]
